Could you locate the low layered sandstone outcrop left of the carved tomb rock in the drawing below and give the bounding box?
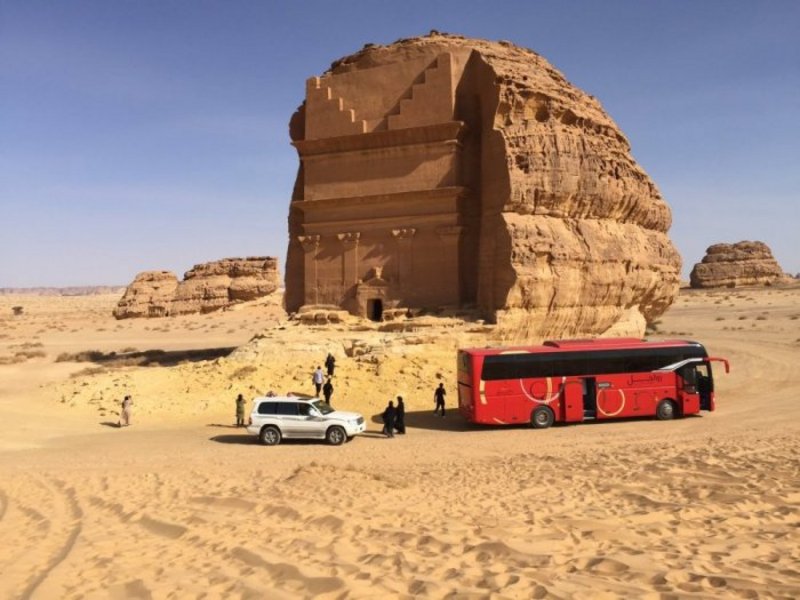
[114,256,279,319]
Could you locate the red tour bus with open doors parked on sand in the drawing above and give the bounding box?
[458,338,729,429]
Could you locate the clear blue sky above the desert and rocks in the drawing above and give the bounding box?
[0,0,800,287]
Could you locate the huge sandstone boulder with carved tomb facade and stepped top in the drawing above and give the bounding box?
[286,33,681,337]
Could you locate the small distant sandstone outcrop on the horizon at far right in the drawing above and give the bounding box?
[689,241,788,288]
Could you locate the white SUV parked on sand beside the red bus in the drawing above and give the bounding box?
[247,396,367,446]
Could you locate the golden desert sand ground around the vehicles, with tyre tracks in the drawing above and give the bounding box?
[0,287,800,599]
